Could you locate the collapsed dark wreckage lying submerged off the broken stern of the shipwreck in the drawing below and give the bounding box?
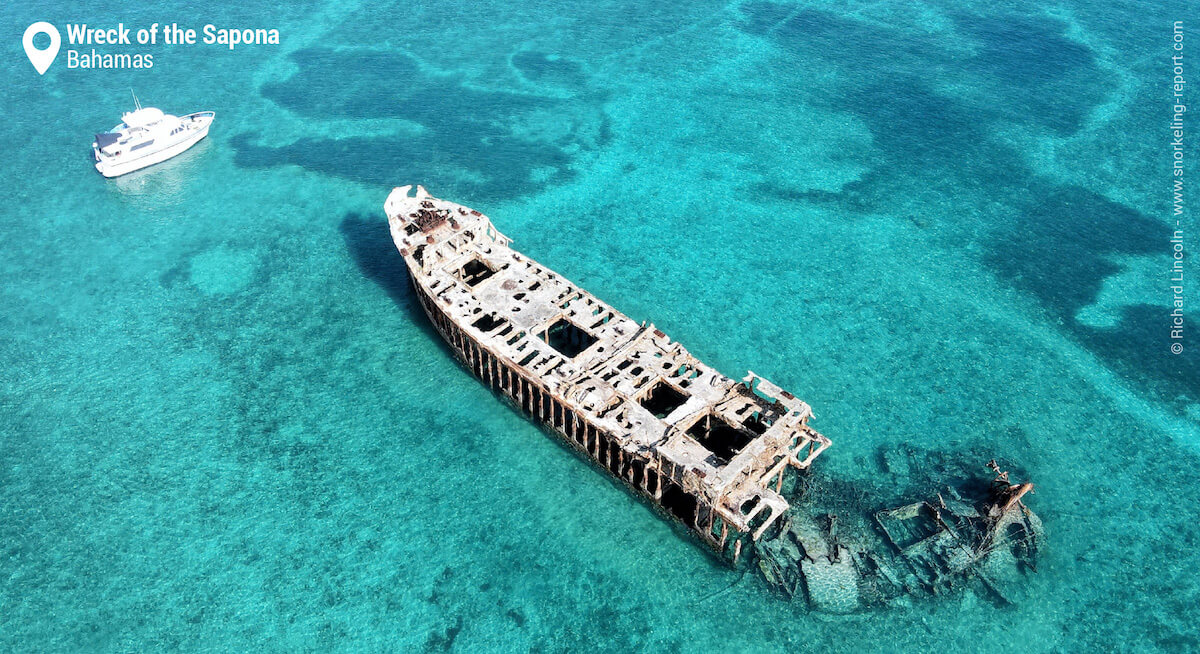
[755,461,1044,613]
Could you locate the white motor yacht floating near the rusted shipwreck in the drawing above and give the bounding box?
[91,97,216,178]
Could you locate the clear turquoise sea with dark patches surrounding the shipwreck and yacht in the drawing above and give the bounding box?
[0,0,1200,652]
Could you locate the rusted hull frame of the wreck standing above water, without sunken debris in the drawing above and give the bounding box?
[384,186,829,565]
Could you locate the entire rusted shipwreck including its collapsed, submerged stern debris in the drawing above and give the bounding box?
[384,186,1043,613]
